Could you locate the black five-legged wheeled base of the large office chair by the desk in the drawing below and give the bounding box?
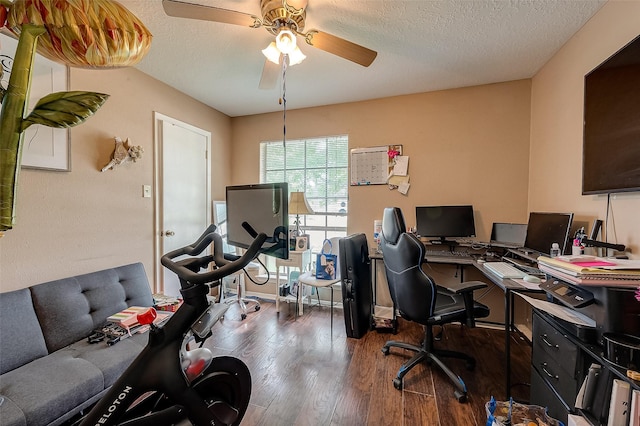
[382,326,476,402]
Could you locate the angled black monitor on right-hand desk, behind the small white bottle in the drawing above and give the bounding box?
[524,212,573,256]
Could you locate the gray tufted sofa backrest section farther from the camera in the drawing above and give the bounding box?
[31,263,153,352]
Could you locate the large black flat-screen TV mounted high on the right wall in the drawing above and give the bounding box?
[582,36,640,194]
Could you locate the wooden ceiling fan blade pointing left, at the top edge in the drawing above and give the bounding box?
[162,0,260,27]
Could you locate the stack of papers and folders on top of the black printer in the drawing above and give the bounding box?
[538,256,640,287]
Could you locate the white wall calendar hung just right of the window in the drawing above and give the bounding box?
[350,145,402,186]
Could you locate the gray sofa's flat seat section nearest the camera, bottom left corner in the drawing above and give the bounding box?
[0,351,104,425]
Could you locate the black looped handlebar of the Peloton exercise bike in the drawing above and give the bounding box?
[160,225,267,284]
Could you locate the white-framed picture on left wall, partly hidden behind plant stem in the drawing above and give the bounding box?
[0,34,71,172]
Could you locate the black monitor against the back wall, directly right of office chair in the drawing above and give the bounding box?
[416,205,476,243]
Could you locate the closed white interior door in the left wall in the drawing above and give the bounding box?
[155,113,211,296]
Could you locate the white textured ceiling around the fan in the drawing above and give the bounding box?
[119,0,605,117]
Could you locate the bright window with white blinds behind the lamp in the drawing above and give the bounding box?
[260,135,349,253]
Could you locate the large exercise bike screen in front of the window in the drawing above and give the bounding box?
[226,182,289,259]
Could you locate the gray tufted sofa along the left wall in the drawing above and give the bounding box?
[0,263,153,426]
